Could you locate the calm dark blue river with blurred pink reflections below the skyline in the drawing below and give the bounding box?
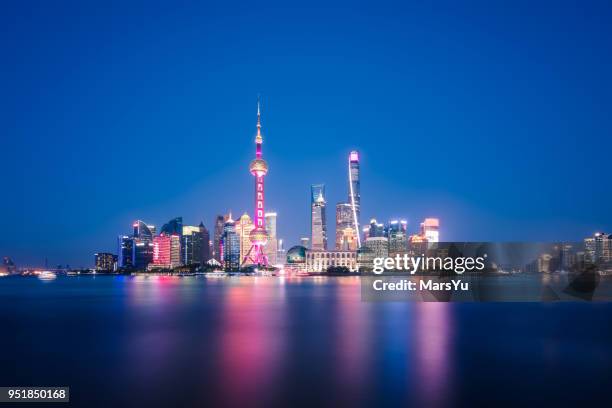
[0,276,612,407]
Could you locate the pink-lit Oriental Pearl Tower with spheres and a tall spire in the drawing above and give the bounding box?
[242,99,268,266]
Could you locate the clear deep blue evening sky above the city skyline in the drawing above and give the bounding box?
[0,1,612,266]
